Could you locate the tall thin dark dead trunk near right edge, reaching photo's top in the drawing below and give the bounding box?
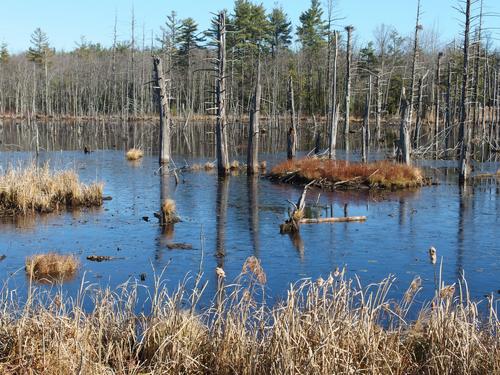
[458,0,471,185]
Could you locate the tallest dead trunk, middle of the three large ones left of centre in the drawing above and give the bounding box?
[216,12,229,176]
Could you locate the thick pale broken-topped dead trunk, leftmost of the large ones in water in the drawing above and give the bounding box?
[153,56,170,164]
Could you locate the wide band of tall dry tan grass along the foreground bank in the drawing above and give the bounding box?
[0,258,500,375]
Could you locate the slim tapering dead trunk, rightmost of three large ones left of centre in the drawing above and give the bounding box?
[247,56,262,174]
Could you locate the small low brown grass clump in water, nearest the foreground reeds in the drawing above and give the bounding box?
[25,253,80,281]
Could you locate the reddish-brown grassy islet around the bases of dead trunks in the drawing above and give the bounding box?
[270,158,425,189]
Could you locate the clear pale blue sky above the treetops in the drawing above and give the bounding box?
[0,0,500,52]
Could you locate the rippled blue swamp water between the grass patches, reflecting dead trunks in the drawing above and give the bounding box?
[0,121,500,312]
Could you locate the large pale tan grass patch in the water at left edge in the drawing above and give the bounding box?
[0,163,103,216]
